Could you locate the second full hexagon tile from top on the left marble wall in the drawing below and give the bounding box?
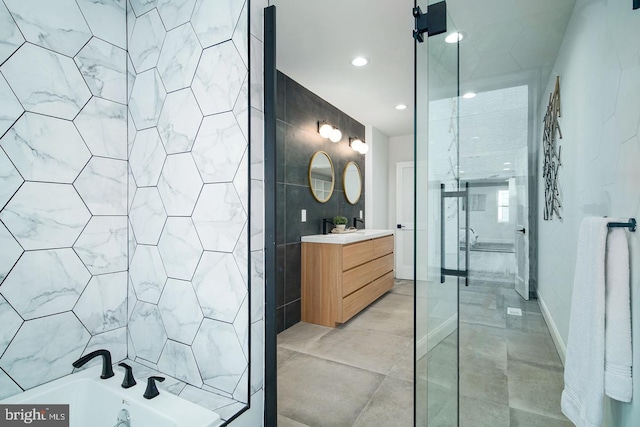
[0,113,91,184]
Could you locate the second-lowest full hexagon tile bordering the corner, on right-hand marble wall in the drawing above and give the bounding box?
[129,245,167,304]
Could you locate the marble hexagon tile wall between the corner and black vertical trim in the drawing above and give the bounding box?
[127,0,252,417]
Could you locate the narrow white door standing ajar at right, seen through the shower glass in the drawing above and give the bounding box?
[509,176,529,300]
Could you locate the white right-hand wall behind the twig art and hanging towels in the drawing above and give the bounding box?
[538,0,640,426]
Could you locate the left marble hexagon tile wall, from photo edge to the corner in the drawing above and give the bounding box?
[0,0,128,398]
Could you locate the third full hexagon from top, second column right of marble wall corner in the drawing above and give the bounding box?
[158,153,202,216]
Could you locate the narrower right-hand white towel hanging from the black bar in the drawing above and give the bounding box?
[604,228,633,402]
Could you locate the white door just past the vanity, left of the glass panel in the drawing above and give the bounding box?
[395,162,414,280]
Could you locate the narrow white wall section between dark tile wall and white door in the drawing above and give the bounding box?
[364,126,389,229]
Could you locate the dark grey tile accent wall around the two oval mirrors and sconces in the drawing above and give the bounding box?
[276,72,365,332]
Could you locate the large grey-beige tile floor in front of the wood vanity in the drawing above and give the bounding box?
[278,280,572,427]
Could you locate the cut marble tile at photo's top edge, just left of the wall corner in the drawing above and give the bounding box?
[78,0,127,49]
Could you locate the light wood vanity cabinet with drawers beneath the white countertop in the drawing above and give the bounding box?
[302,235,394,328]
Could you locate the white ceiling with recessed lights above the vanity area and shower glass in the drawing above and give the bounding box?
[271,0,575,136]
